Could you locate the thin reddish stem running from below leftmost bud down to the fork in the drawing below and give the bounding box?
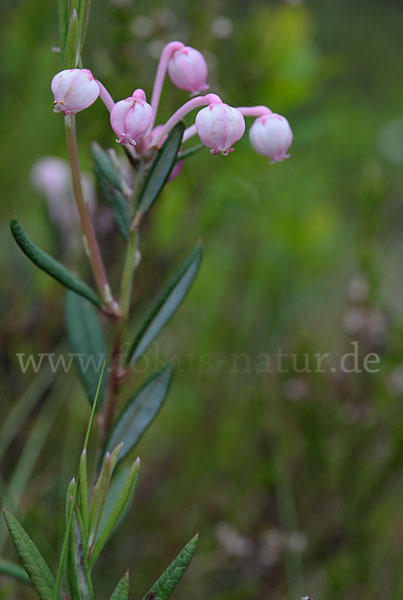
[65,114,120,319]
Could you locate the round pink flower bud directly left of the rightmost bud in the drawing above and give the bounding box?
[196,102,245,156]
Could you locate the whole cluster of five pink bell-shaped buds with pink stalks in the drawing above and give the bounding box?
[51,42,292,163]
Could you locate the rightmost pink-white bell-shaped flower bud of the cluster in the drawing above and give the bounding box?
[249,113,292,164]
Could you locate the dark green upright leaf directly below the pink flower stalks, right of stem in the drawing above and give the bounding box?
[138,121,185,217]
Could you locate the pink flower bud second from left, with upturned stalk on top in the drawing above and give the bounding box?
[111,90,153,146]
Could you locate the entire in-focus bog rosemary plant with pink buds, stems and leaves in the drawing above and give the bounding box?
[0,0,292,600]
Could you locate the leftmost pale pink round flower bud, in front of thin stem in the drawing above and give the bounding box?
[50,69,99,115]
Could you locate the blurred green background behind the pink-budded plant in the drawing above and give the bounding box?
[0,0,403,600]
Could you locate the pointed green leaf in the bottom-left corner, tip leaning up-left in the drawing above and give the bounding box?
[3,509,55,600]
